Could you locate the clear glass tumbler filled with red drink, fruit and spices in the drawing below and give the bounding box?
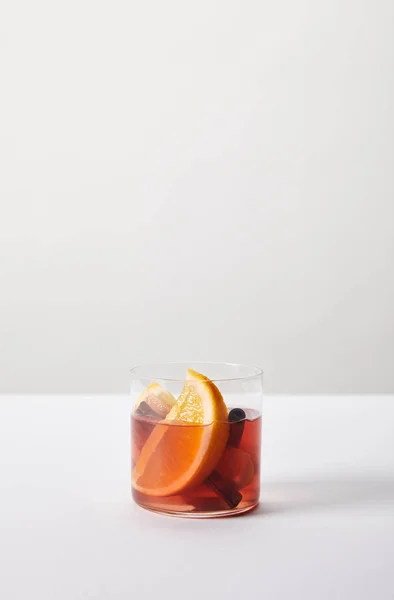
[131,363,263,517]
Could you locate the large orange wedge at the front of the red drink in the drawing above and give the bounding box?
[133,369,229,496]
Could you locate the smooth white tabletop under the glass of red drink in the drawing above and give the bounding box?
[0,396,394,600]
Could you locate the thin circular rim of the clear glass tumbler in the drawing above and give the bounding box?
[129,360,264,383]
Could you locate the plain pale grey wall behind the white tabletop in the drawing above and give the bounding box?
[0,0,394,393]
